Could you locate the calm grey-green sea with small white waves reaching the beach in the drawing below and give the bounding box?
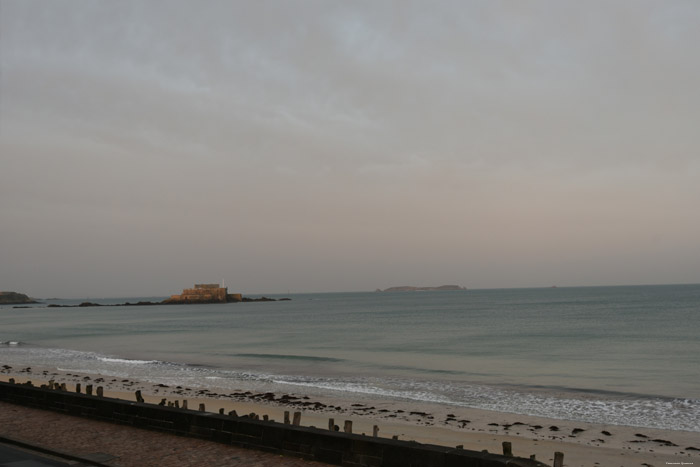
[0,285,700,432]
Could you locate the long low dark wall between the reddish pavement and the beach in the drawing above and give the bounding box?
[0,382,546,467]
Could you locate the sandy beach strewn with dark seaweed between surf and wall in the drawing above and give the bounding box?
[0,365,700,467]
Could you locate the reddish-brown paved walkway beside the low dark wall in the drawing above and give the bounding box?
[0,402,327,467]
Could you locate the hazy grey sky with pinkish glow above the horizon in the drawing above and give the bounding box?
[0,0,700,298]
